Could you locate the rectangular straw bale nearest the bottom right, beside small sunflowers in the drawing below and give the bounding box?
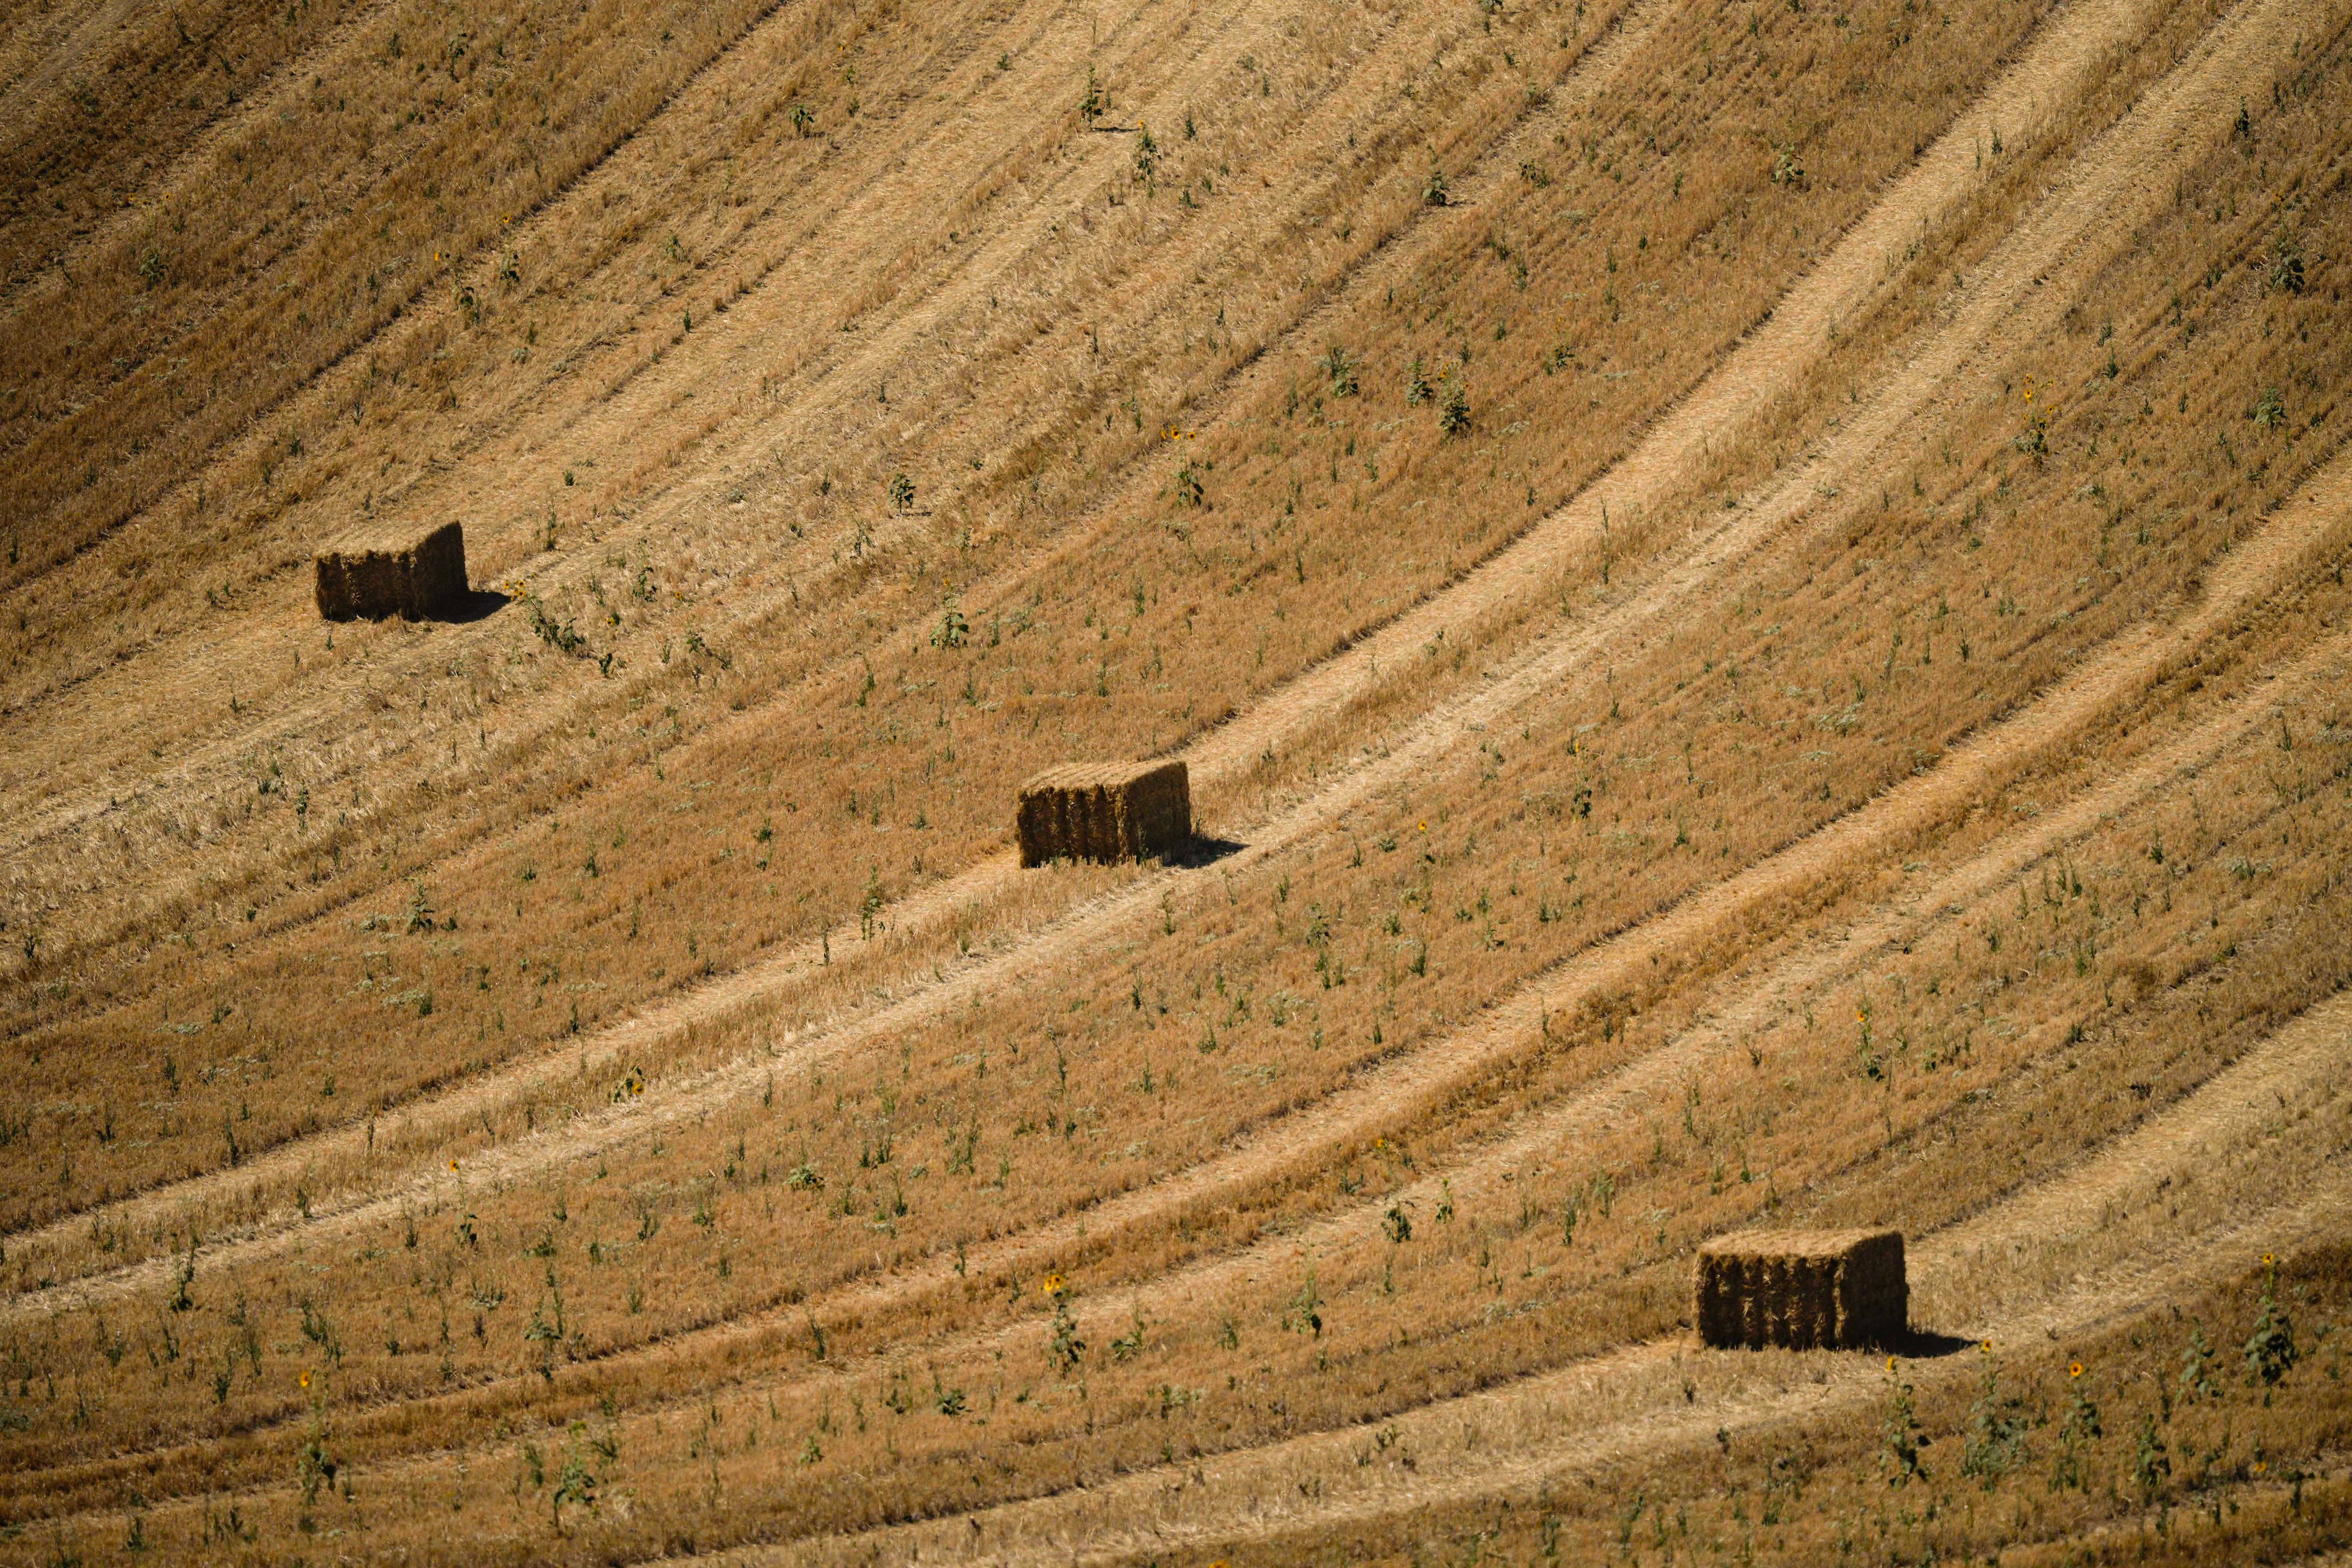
[1696,1229,1910,1349]
